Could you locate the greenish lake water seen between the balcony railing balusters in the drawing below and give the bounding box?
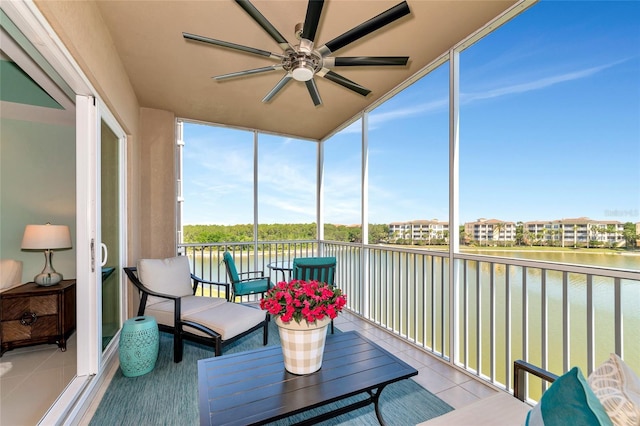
[192,249,640,398]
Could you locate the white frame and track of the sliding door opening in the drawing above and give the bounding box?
[0,0,126,424]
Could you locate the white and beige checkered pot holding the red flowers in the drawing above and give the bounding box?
[275,316,331,375]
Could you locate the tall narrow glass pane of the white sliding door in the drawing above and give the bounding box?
[100,121,122,350]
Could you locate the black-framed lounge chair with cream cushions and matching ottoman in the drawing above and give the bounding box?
[124,256,268,362]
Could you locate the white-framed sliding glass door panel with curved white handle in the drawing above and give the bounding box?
[76,96,126,374]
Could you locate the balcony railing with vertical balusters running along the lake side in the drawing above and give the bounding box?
[180,241,640,400]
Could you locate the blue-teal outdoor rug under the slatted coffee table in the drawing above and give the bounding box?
[90,321,452,426]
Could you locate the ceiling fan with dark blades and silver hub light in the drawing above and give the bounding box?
[182,0,410,106]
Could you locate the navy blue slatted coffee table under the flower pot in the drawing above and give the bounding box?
[198,331,418,425]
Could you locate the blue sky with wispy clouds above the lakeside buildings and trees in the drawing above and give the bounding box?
[184,0,640,224]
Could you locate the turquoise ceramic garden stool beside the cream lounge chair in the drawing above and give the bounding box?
[120,316,160,377]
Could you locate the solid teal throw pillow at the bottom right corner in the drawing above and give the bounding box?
[525,367,613,426]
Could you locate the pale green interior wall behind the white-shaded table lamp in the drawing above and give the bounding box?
[0,118,76,282]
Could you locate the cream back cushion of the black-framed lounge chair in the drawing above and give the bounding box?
[138,256,193,304]
